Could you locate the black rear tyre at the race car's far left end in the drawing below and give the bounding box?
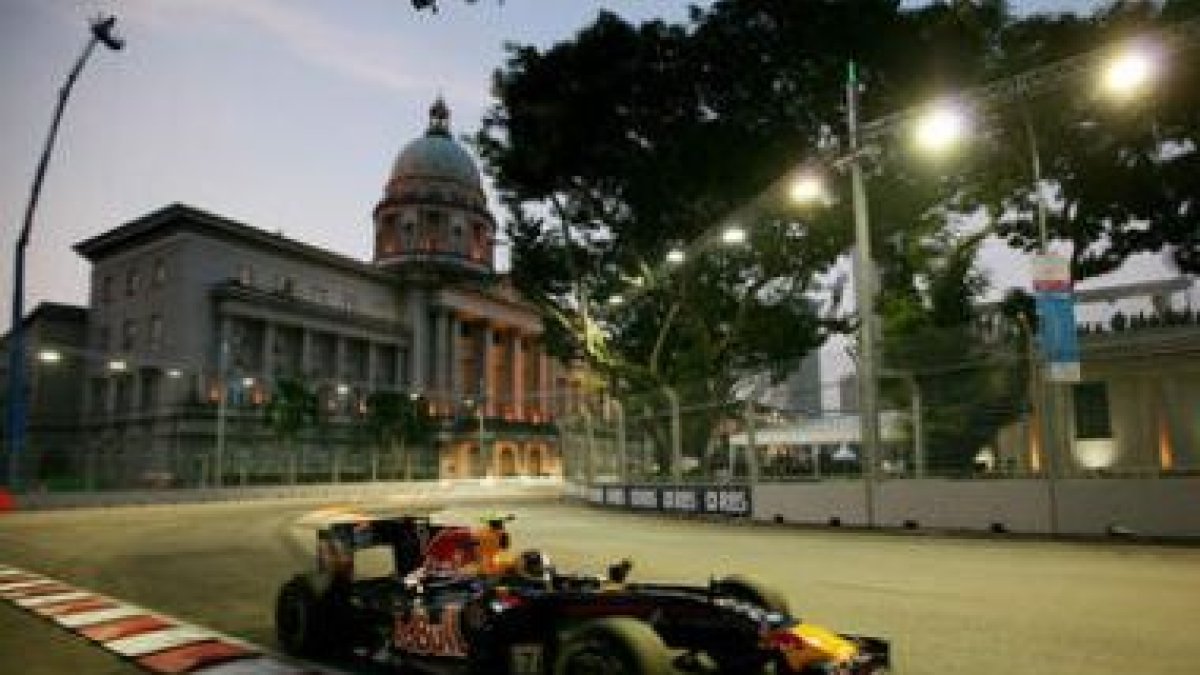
[275,575,348,657]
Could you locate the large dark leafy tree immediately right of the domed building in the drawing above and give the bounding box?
[476,0,1008,471]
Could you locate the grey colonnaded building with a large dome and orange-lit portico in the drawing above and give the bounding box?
[62,100,568,485]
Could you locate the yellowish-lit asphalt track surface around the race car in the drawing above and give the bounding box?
[0,502,1200,675]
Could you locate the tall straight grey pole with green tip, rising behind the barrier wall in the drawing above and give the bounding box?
[846,61,880,527]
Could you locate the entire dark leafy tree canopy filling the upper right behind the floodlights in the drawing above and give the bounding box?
[476,0,1200,473]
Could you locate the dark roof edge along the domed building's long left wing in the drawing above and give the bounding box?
[73,202,392,280]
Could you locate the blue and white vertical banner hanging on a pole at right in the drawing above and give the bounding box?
[1033,255,1080,382]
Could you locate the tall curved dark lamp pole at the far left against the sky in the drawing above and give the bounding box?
[8,17,125,491]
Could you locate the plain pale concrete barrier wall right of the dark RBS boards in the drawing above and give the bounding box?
[752,478,1200,538]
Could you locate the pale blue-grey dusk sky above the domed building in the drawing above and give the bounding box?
[0,0,1152,330]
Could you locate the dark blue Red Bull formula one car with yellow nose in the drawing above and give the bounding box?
[276,516,890,675]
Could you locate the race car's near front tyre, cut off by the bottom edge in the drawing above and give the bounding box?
[554,617,671,675]
